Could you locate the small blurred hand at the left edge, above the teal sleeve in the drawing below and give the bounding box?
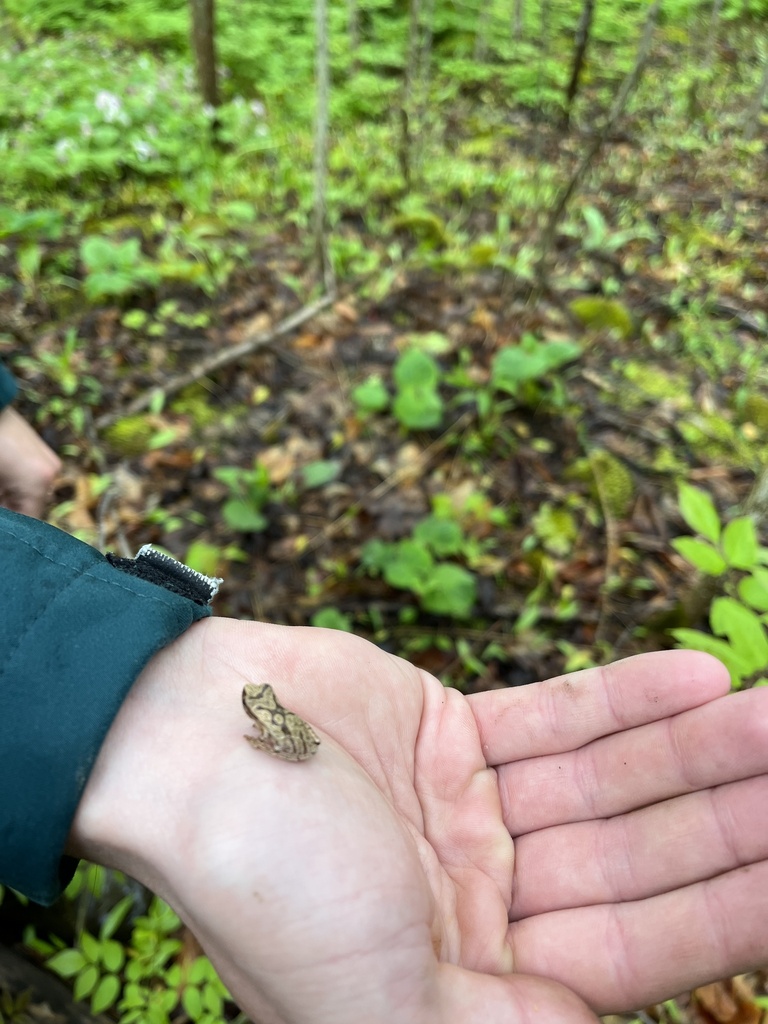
[0,407,61,518]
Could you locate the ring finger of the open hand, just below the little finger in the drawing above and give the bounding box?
[497,687,768,836]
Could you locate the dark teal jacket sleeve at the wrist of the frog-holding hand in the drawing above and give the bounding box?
[0,509,215,904]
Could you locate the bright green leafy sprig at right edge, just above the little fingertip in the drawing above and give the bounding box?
[671,483,768,688]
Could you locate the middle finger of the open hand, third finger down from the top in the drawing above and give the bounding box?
[510,775,768,921]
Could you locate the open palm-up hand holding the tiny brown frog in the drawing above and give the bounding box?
[71,618,768,1024]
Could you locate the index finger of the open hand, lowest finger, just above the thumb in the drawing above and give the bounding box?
[508,862,768,1014]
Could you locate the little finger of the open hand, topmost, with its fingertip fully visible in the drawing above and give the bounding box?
[468,650,729,765]
